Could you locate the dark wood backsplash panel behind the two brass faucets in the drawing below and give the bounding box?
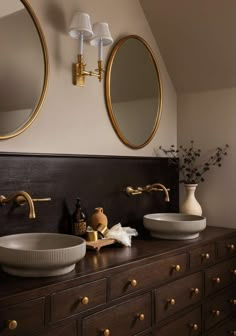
[0,153,179,236]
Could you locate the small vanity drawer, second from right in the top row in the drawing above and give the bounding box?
[189,243,216,269]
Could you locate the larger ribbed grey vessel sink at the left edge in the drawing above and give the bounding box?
[0,233,86,277]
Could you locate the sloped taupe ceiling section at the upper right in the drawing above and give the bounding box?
[140,0,236,93]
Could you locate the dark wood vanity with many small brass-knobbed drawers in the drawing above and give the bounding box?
[0,227,236,336]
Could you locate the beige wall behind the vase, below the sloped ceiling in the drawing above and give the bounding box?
[178,88,236,228]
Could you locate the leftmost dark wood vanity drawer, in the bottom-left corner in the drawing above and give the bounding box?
[0,298,44,336]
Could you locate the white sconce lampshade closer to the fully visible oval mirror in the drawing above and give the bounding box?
[90,22,113,47]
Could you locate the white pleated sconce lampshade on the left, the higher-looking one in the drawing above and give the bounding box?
[68,12,93,40]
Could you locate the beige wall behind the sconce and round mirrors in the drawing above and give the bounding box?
[0,0,177,156]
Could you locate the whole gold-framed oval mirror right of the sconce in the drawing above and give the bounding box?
[105,35,162,149]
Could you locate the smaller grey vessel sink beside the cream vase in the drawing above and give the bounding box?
[143,213,206,240]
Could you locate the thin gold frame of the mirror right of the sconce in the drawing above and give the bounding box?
[105,35,162,149]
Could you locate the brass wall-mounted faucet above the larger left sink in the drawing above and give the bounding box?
[0,191,51,218]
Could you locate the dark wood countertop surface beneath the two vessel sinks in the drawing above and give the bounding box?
[0,226,236,307]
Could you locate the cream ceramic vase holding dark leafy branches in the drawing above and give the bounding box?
[180,184,202,216]
